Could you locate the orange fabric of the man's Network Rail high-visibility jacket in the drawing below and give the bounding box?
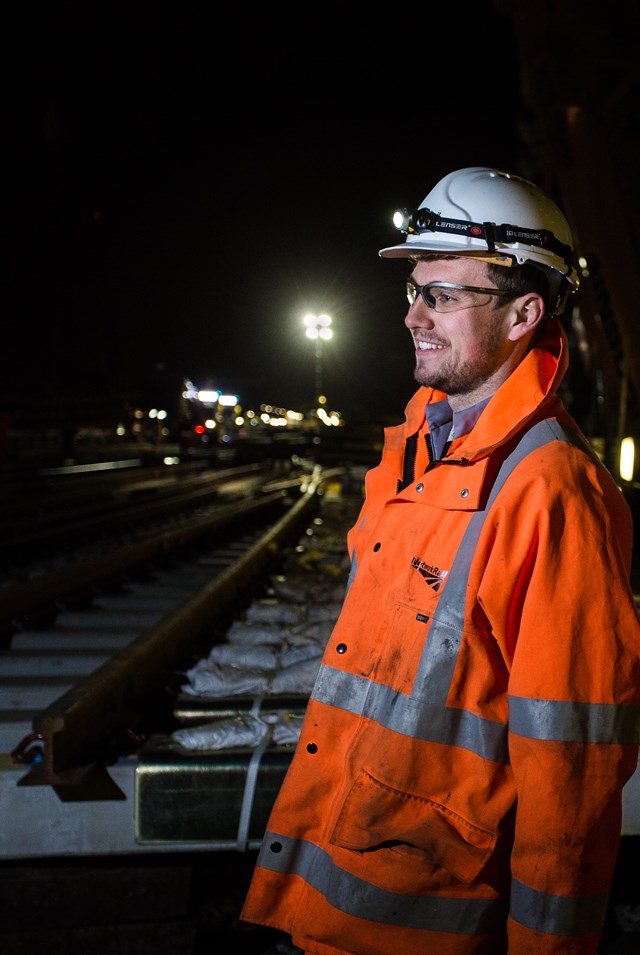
[243,322,640,955]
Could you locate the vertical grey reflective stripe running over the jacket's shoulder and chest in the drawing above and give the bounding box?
[414,419,569,706]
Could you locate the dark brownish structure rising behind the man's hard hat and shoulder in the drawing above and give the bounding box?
[494,0,640,497]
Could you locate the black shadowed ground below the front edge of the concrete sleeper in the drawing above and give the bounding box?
[0,844,640,955]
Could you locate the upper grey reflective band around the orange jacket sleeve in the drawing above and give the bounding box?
[509,696,640,743]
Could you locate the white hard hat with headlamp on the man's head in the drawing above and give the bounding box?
[379,166,579,295]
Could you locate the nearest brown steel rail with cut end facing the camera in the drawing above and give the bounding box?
[14,471,323,800]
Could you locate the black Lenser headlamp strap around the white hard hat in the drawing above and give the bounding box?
[400,208,574,269]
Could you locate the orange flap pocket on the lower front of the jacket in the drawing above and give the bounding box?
[331,770,497,882]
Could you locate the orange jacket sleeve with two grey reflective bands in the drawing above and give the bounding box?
[479,447,640,955]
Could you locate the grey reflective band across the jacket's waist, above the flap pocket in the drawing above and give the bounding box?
[311,664,509,763]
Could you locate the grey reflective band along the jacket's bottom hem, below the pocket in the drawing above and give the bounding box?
[257,832,507,935]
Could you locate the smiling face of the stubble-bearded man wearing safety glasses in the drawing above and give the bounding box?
[405,258,515,410]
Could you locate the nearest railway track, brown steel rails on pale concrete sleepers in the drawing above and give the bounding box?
[0,467,352,859]
